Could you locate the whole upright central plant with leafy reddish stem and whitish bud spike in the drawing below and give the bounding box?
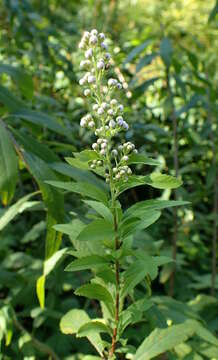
[50,29,189,360]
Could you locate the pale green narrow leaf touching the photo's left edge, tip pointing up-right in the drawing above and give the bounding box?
[0,191,39,231]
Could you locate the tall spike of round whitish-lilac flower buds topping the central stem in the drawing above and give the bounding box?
[79,29,137,182]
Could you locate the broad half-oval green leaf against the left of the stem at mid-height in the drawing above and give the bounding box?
[77,219,115,241]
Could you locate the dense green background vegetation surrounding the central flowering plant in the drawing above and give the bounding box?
[0,0,218,360]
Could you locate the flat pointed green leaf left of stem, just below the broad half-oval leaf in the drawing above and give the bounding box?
[65,255,108,271]
